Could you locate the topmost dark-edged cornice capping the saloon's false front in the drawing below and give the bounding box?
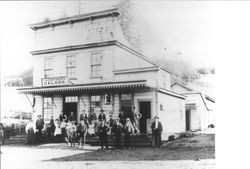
[29,8,120,30]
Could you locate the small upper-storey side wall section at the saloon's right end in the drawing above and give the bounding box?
[157,69,171,90]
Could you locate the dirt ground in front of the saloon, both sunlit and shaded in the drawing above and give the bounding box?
[1,134,215,169]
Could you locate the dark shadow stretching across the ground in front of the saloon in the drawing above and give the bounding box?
[43,134,215,162]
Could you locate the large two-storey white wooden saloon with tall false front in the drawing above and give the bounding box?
[19,9,186,136]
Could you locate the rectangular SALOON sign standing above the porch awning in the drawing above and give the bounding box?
[42,76,68,86]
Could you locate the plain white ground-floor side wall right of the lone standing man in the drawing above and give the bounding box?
[158,92,186,133]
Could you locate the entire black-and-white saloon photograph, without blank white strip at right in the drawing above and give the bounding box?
[0,0,239,169]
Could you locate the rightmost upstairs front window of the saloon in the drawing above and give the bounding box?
[91,52,102,77]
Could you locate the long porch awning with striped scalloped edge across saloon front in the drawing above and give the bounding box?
[17,80,147,94]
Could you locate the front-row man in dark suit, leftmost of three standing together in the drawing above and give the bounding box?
[98,120,109,149]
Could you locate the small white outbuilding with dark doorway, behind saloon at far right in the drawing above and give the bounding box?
[171,82,215,131]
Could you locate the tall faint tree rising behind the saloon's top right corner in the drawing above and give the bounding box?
[114,0,141,51]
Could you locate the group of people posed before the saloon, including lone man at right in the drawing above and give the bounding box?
[26,107,162,149]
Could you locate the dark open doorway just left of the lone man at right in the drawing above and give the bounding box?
[139,101,151,134]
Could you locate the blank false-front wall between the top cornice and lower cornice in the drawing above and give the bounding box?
[34,17,118,50]
